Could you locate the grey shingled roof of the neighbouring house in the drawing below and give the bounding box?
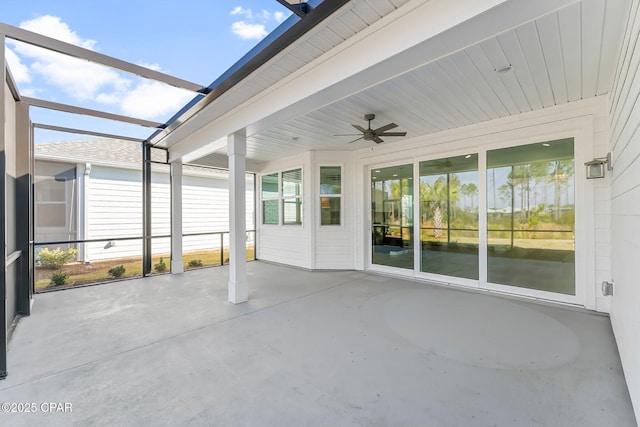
[34,138,238,179]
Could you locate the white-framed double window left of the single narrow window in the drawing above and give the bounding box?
[262,169,302,225]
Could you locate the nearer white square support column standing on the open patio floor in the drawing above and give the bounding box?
[227,129,249,304]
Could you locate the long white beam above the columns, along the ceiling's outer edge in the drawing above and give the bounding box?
[165,0,578,162]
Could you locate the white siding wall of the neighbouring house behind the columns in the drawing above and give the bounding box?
[38,166,255,261]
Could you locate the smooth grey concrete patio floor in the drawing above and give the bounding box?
[0,262,636,427]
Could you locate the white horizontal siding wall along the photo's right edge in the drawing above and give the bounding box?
[608,0,640,416]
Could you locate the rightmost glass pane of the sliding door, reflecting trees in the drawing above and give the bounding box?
[487,138,575,295]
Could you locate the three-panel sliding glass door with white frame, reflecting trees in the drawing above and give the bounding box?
[371,138,576,301]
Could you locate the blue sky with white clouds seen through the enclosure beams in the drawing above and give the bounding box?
[0,0,290,142]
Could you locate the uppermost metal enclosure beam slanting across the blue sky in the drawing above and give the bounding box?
[0,22,208,93]
